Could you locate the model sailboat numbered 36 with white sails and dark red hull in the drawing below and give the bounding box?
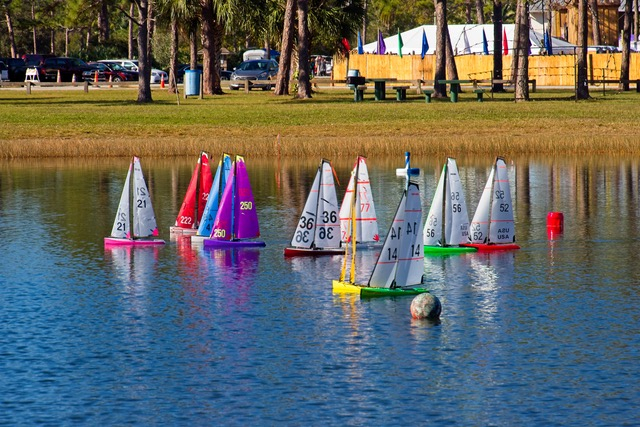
[284,159,343,256]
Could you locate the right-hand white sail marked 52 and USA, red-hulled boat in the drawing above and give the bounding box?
[489,158,515,243]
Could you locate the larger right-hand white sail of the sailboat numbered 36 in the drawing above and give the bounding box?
[314,160,340,248]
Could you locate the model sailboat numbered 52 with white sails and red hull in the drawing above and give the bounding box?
[465,157,520,251]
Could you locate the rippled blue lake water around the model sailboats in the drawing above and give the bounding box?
[0,153,640,426]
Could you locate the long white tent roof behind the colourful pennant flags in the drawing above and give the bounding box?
[363,24,576,55]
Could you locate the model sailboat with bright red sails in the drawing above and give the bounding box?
[169,151,212,236]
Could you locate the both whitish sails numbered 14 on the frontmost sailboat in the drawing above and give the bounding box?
[369,183,424,288]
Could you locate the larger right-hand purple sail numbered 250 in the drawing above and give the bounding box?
[234,156,260,239]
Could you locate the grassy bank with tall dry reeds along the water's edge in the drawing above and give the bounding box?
[0,88,640,158]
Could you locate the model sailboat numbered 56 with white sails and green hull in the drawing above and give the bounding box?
[423,158,476,254]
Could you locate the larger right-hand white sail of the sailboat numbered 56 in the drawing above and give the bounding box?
[445,158,469,246]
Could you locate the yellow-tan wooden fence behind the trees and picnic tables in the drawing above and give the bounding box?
[333,53,640,86]
